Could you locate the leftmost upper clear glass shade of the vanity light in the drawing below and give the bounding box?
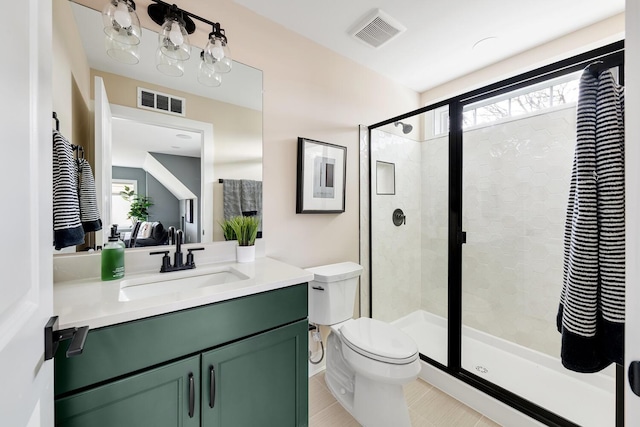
[102,0,142,45]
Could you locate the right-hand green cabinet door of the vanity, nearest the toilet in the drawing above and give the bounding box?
[201,321,309,427]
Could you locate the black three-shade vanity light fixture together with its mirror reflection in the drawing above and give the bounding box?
[102,0,233,87]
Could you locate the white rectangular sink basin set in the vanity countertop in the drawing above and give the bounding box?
[118,267,249,301]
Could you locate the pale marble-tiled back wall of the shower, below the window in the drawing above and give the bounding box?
[420,107,575,357]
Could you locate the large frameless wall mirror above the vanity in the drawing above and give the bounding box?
[53,0,262,252]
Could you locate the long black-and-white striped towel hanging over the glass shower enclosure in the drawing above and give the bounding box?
[557,71,625,372]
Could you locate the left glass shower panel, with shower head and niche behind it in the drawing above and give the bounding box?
[370,107,449,364]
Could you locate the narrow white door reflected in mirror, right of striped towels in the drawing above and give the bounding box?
[94,76,112,246]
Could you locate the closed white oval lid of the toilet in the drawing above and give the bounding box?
[340,317,418,364]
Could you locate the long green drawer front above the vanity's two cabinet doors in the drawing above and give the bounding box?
[54,284,307,396]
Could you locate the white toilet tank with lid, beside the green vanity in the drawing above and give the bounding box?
[307,262,362,325]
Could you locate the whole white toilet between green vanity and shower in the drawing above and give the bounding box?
[307,262,420,427]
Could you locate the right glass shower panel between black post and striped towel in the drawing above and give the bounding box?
[461,67,615,427]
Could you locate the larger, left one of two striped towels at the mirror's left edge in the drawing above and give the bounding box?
[53,130,84,249]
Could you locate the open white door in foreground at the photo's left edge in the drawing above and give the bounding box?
[0,0,53,427]
